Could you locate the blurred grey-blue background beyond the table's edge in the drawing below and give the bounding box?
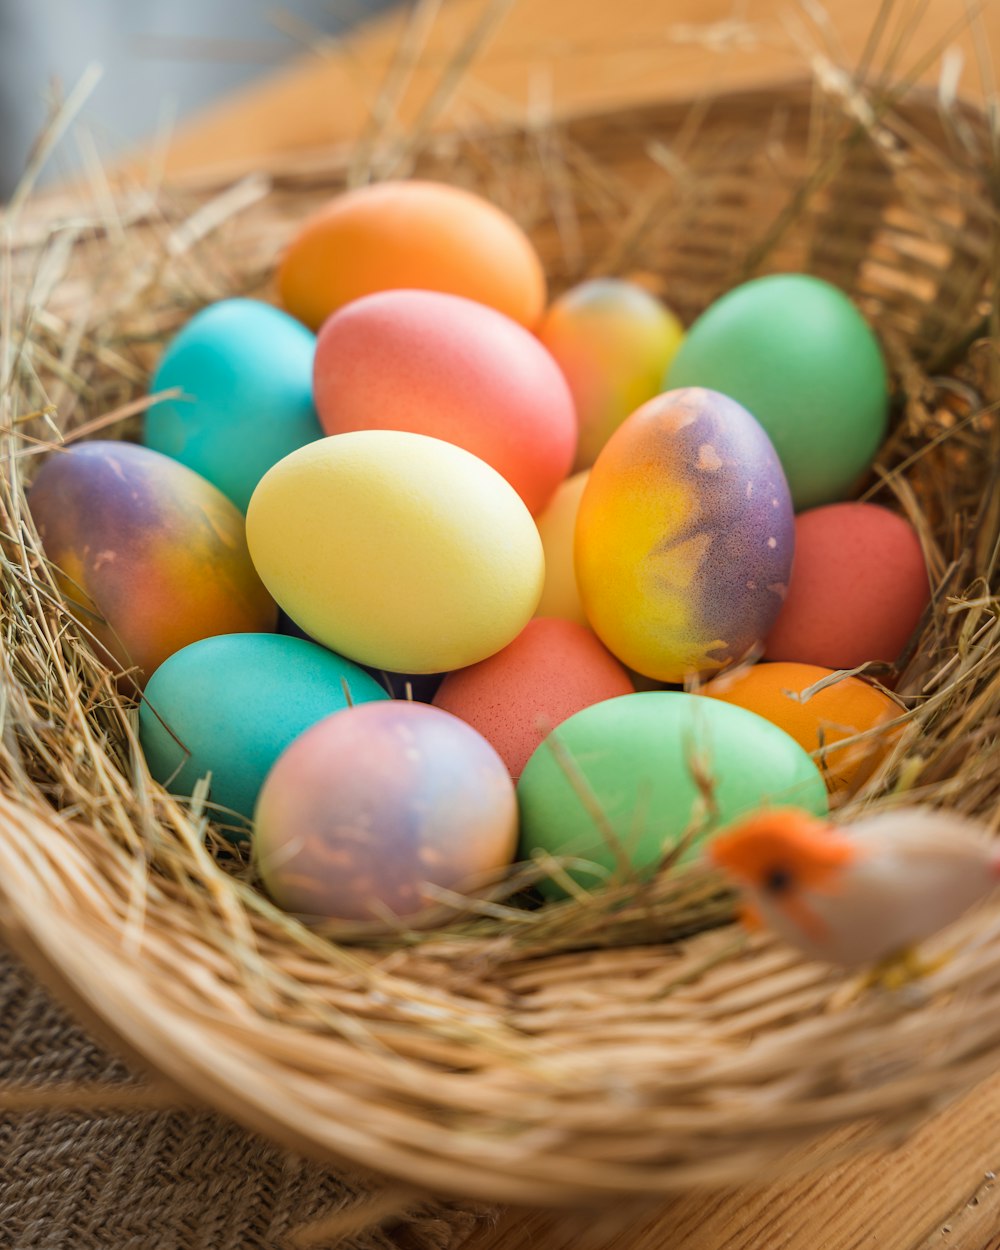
[0,0,394,201]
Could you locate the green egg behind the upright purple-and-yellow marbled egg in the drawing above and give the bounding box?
[664,274,889,511]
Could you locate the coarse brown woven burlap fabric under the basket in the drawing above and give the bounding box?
[0,949,487,1250]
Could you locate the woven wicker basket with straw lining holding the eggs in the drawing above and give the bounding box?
[0,36,1000,1220]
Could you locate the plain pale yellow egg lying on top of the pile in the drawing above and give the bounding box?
[246,430,545,673]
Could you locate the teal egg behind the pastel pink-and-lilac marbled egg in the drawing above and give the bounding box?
[139,634,388,820]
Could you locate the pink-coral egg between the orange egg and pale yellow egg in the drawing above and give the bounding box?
[314,291,576,513]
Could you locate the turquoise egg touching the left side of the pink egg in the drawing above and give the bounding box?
[143,300,323,511]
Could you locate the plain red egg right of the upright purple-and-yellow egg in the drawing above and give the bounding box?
[764,503,930,669]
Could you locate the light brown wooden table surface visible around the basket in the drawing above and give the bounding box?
[156,0,1000,1250]
